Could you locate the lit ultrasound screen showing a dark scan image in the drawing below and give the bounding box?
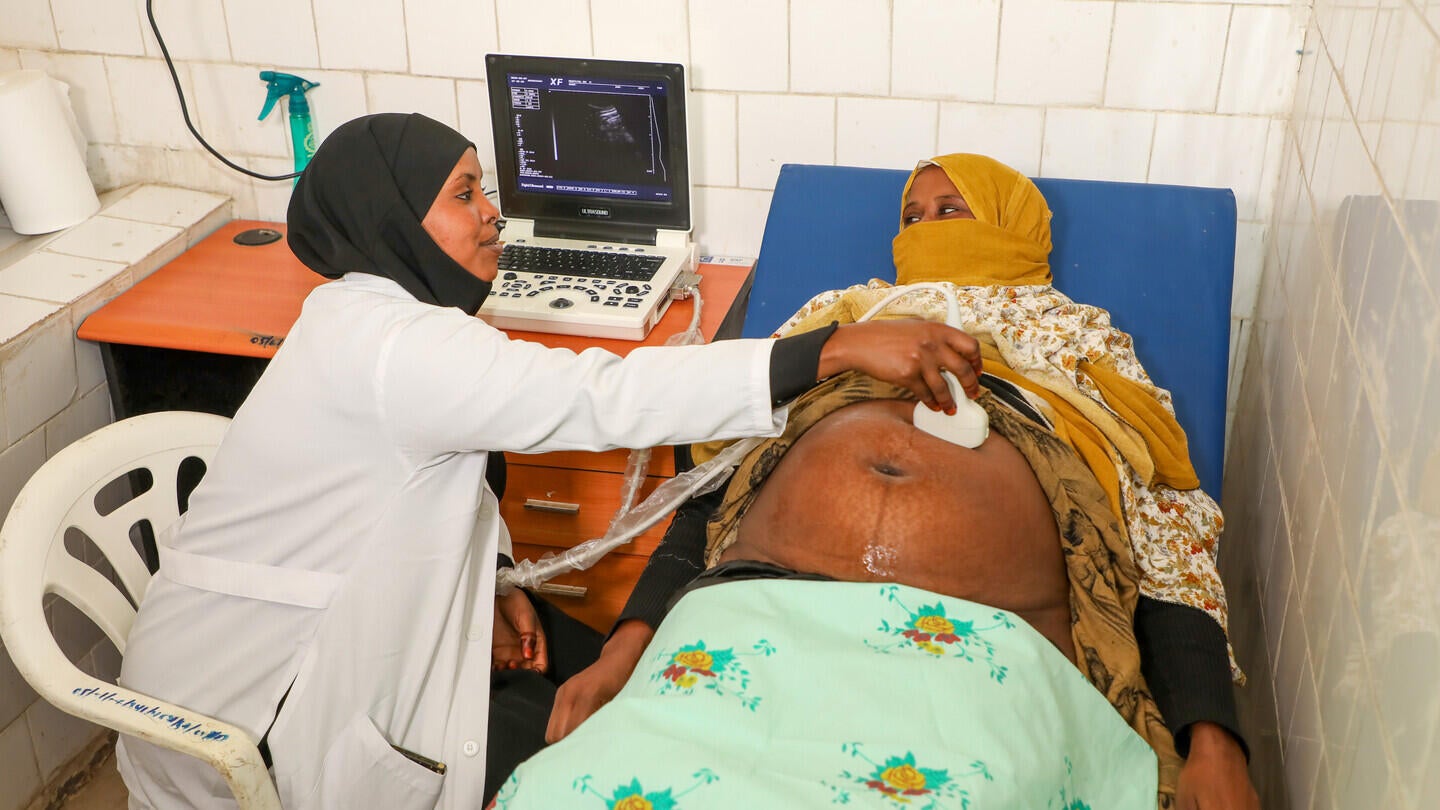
[507,74,675,203]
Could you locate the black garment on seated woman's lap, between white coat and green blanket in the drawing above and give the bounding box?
[484,595,605,804]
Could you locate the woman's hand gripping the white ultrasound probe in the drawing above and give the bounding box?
[819,319,984,414]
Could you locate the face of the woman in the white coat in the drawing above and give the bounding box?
[420,148,501,281]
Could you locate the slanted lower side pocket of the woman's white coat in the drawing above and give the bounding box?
[305,712,445,810]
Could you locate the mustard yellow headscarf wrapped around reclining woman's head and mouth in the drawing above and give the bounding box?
[891,154,1050,287]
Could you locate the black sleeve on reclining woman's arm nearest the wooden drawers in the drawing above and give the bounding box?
[611,484,726,633]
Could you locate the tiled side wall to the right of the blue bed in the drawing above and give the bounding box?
[1221,0,1440,810]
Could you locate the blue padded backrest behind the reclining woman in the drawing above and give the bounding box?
[743,164,1236,500]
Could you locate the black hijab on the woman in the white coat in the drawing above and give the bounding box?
[285,112,490,314]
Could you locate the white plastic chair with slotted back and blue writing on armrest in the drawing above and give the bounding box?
[0,411,279,810]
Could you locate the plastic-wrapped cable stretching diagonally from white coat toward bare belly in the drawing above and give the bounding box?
[495,429,762,595]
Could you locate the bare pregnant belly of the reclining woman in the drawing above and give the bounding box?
[721,399,1074,660]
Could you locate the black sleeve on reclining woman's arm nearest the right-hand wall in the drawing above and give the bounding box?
[1135,597,1250,758]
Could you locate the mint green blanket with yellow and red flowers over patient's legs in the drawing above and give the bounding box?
[494,579,1156,810]
